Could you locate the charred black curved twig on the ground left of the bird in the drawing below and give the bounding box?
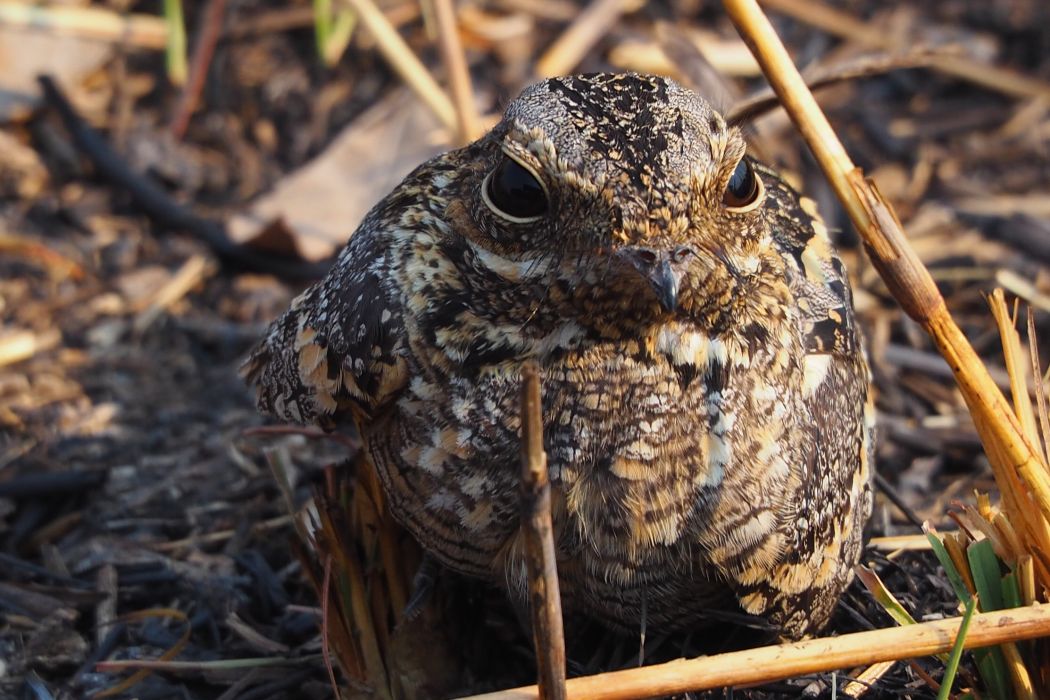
[38,76,331,280]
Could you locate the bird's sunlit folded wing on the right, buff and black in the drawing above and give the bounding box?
[726,166,875,638]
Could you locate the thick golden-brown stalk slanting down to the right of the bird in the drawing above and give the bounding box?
[725,0,1050,517]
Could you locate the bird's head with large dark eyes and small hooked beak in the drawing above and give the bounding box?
[455,73,775,333]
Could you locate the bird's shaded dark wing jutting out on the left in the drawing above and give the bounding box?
[242,217,408,426]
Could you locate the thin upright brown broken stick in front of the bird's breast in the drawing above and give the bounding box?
[522,362,565,700]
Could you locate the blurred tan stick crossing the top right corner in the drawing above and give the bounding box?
[762,0,1050,98]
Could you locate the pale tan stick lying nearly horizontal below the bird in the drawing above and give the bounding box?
[464,606,1050,700]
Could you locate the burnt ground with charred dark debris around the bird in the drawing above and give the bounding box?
[0,0,1050,699]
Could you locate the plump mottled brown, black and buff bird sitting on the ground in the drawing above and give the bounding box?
[245,75,873,637]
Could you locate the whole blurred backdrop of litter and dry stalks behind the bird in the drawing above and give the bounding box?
[0,0,1050,699]
